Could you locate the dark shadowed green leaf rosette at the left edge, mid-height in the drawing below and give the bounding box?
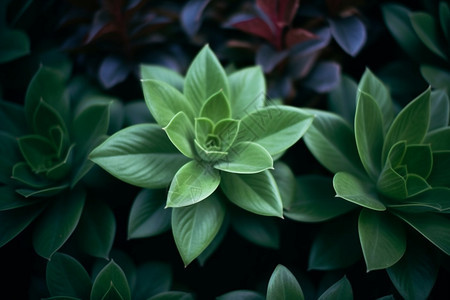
[0,66,115,258]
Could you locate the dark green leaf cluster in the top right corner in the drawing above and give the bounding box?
[382,1,450,93]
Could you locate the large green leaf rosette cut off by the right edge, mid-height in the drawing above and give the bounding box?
[286,70,450,298]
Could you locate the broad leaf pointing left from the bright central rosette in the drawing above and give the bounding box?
[90,124,188,188]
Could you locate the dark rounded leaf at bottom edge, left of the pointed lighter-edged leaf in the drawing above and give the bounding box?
[46,253,92,299]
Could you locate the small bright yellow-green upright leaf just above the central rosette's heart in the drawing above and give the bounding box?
[200,90,231,124]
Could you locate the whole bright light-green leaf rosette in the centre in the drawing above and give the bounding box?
[90,46,312,265]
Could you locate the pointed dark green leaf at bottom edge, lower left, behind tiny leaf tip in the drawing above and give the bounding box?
[90,260,131,300]
